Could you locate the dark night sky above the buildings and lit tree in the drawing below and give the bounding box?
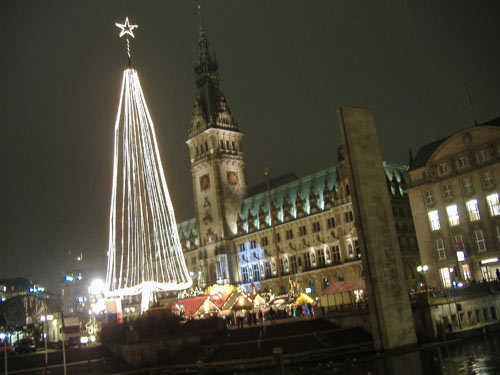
[0,0,500,294]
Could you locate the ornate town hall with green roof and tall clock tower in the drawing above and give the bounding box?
[174,18,420,293]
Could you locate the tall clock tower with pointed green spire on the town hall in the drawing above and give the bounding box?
[186,14,247,282]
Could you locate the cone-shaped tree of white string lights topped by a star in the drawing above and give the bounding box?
[105,18,192,311]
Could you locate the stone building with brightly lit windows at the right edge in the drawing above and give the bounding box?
[408,118,500,287]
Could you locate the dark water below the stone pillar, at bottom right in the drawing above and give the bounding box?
[287,333,500,375]
